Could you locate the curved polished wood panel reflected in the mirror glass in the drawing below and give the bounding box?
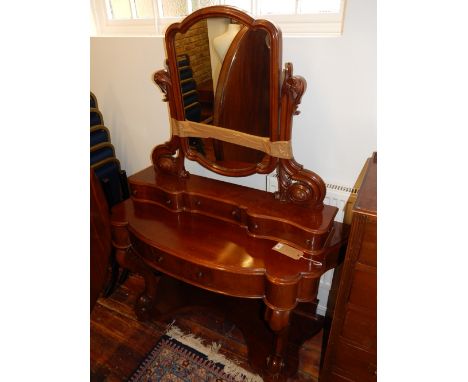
[213,27,275,166]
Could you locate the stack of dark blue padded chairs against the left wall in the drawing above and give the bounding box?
[90,93,129,297]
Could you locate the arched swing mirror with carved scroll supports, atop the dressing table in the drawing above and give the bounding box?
[152,6,326,205]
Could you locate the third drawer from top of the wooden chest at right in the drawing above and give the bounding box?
[341,306,377,351]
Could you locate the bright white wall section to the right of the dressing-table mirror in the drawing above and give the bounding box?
[283,0,377,186]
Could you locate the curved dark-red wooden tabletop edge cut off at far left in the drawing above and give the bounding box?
[90,169,112,310]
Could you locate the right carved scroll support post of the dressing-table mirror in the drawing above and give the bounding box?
[275,63,326,204]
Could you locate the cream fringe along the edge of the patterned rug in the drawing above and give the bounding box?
[166,320,263,382]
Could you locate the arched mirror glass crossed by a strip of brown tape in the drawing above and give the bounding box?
[174,17,271,168]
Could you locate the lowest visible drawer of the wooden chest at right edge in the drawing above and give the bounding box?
[332,338,377,382]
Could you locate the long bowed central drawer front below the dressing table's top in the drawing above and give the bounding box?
[131,237,265,298]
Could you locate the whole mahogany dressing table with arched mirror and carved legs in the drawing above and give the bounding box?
[111,6,347,379]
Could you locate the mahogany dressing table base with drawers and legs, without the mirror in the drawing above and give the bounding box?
[112,167,347,379]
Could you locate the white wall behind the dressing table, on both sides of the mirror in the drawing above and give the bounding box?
[91,0,377,188]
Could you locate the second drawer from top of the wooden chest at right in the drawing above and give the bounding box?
[349,267,377,312]
